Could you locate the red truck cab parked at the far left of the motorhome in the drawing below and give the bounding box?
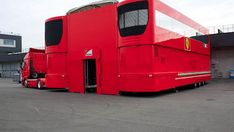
[21,48,46,88]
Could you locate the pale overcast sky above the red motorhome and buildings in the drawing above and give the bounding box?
[0,0,234,48]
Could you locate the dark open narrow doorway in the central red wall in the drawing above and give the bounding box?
[84,59,97,93]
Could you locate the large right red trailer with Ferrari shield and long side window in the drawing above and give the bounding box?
[118,0,210,92]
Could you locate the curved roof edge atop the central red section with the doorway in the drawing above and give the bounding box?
[67,0,118,15]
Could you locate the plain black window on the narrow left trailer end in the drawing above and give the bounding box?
[45,19,63,46]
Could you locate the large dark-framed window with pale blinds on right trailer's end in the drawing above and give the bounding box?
[118,1,148,37]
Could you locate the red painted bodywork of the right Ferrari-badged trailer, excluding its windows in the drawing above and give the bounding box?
[118,0,210,92]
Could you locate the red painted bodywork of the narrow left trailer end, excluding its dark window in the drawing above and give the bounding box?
[45,16,68,89]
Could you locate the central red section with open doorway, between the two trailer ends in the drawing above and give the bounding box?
[67,1,118,94]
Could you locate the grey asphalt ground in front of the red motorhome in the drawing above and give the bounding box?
[0,79,234,132]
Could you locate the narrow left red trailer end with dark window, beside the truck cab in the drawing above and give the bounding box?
[45,16,68,89]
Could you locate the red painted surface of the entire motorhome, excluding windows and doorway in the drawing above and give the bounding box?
[43,0,210,94]
